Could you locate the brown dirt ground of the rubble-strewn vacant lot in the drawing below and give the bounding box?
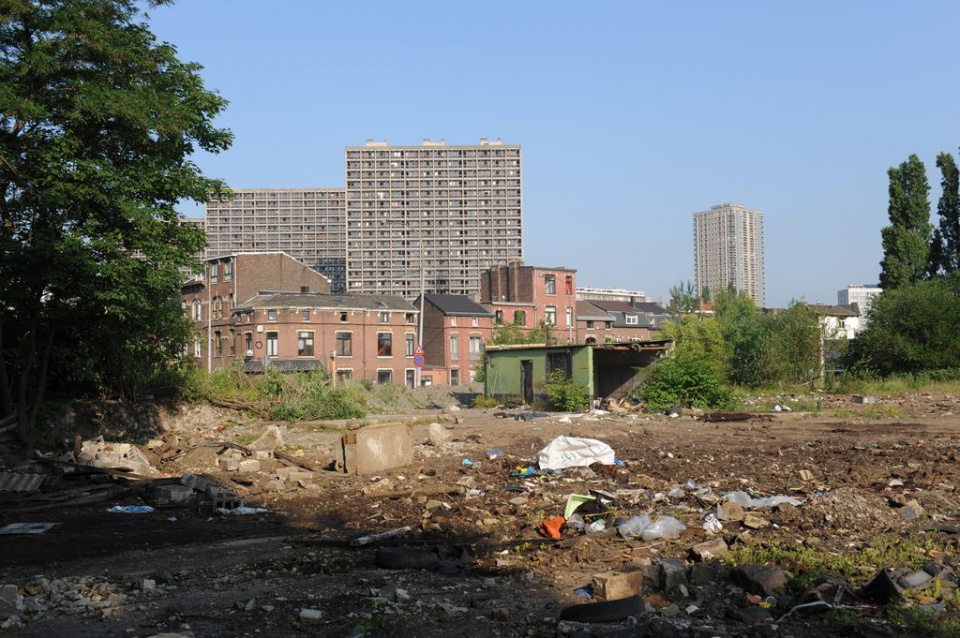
[0,394,960,638]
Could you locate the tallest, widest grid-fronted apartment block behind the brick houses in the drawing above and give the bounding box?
[346,139,523,299]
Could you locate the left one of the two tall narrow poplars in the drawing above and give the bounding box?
[880,155,932,290]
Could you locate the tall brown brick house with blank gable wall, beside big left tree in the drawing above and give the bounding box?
[181,252,330,370]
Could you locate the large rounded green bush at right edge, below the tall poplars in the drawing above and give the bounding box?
[844,273,960,376]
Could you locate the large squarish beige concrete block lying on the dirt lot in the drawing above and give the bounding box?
[341,423,413,474]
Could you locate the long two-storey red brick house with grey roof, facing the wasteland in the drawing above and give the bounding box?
[233,292,419,387]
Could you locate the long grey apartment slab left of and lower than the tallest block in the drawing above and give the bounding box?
[204,188,346,292]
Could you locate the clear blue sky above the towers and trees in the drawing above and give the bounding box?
[150,0,960,306]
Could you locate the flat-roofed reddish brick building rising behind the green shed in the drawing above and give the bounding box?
[480,263,577,343]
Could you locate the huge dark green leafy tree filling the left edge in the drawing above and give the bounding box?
[0,0,231,442]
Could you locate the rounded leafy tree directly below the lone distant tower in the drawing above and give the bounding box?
[715,286,771,386]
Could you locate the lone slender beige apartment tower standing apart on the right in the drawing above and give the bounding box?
[693,204,766,307]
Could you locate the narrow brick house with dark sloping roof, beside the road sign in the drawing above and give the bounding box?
[414,293,493,385]
